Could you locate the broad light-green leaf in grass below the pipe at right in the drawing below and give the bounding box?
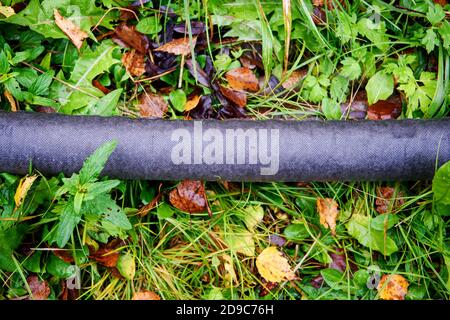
[346,214,398,256]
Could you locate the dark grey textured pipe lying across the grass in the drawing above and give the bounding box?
[0,112,450,181]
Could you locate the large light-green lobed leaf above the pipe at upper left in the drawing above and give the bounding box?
[51,40,119,114]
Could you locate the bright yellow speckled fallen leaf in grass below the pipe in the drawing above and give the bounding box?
[256,247,297,282]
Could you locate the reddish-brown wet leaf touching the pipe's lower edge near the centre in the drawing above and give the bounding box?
[169,180,207,213]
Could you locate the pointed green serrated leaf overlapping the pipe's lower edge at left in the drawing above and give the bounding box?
[79,140,117,184]
